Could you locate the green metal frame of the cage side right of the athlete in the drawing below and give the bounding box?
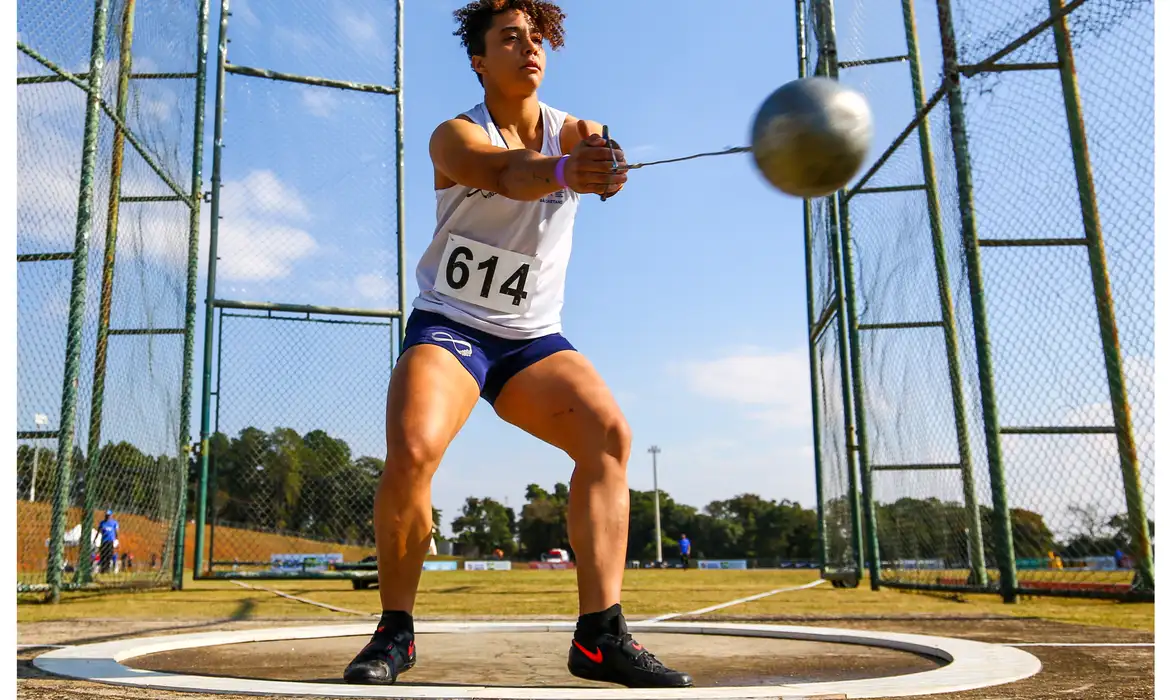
[796,0,1154,603]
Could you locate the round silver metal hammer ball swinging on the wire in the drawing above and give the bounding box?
[751,77,873,198]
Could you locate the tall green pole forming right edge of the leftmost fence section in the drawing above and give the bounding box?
[172,0,209,589]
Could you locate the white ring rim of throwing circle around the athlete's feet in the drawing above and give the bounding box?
[33,622,1040,700]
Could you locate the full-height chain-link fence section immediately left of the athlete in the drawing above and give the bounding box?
[194,0,405,577]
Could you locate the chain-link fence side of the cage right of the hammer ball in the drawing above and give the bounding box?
[797,0,1155,598]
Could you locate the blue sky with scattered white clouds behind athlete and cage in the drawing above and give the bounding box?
[21,0,1152,543]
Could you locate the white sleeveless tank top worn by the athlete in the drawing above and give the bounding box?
[413,103,580,339]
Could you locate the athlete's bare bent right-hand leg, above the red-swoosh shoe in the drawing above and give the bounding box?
[495,351,631,615]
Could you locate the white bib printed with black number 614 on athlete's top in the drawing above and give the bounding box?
[435,234,539,314]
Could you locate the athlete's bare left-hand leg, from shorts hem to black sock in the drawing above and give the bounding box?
[373,344,480,612]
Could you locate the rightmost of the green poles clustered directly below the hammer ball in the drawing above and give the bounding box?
[840,198,881,591]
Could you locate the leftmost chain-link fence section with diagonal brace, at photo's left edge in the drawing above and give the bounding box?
[16,0,206,598]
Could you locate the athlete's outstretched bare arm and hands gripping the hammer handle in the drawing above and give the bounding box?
[431,119,626,201]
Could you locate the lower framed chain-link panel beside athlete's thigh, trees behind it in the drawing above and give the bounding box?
[207,313,393,576]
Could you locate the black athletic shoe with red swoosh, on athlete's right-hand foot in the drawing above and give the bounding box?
[569,625,695,688]
